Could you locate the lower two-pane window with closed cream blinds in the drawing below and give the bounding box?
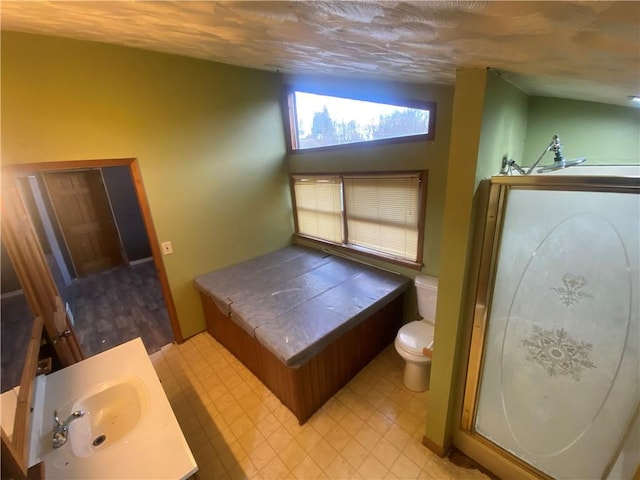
[292,171,427,264]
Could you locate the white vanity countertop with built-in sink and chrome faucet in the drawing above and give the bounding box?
[29,338,198,480]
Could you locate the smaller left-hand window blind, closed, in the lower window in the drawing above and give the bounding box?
[294,175,344,243]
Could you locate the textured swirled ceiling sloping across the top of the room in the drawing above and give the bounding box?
[0,0,640,105]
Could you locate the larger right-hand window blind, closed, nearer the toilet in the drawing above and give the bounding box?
[344,174,420,261]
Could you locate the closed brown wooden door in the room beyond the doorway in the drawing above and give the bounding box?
[44,170,123,276]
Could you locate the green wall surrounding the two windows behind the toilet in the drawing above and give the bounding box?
[285,73,453,277]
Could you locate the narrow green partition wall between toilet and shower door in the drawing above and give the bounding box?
[425,68,527,448]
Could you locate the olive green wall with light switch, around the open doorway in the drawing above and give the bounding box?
[1,32,293,337]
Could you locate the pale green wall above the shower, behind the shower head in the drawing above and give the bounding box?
[514,97,640,165]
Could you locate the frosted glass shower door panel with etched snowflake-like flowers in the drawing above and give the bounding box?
[474,188,640,478]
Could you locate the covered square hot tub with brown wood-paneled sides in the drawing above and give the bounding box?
[196,247,410,424]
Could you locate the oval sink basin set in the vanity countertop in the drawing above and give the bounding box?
[69,377,149,457]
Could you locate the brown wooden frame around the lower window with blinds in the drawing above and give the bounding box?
[289,170,429,270]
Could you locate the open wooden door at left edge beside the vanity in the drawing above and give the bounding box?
[1,177,83,366]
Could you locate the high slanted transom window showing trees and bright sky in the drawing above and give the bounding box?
[288,90,435,151]
